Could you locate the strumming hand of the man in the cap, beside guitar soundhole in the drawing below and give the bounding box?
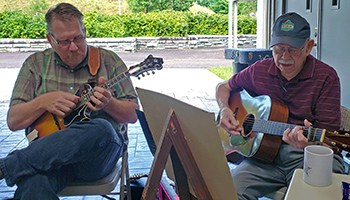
[220,108,242,135]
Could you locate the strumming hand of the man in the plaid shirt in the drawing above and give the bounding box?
[42,91,80,118]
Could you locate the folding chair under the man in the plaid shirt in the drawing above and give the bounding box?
[59,141,131,200]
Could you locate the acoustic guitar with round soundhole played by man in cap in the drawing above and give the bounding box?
[219,90,350,163]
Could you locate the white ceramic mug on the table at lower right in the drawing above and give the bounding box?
[303,145,333,187]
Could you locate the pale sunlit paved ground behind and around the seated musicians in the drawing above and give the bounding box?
[0,50,224,200]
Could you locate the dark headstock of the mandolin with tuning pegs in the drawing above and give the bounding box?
[128,55,163,79]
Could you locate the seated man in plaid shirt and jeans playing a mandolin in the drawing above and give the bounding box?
[0,3,139,199]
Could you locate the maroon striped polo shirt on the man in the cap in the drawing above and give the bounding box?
[229,55,341,130]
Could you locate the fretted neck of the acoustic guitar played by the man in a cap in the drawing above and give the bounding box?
[252,119,326,142]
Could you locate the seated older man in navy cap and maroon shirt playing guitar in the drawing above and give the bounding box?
[216,12,344,199]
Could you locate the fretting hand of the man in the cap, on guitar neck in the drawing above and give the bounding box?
[282,119,312,149]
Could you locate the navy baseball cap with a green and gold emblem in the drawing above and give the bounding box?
[270,12,310,48]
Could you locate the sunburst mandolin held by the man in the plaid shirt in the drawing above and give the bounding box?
[26,55,163,142]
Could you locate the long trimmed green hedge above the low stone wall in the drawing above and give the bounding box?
[0,10,256,39]
